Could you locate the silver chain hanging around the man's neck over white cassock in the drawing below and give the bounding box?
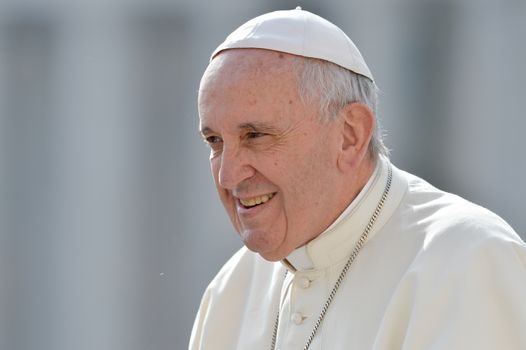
[270,164,393,350]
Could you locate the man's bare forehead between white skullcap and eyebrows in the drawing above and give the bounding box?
[199,49,304,128]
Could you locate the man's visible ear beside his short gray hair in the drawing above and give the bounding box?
[338,103,375,172]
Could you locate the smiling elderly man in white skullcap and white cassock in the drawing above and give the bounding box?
[190,8,526,350]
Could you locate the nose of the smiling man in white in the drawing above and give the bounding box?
[218,147,255,190]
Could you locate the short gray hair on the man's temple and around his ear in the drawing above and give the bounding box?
[294,57,389,159]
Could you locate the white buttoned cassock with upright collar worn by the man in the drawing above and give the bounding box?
[189,158,526,350]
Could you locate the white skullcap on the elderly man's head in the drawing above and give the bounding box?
[210,7,374,80]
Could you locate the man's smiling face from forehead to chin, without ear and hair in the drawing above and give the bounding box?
[199,49,343,261]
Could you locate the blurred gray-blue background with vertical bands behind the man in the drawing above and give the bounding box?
[0,0,526,350]
